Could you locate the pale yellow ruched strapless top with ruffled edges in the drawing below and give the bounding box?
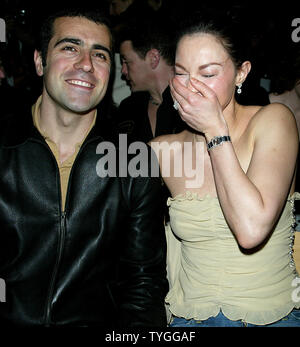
[165,192,300,325]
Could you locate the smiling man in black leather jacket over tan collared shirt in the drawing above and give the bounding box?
[0,11,167,327]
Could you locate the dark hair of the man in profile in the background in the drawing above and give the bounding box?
[117,16,175,66]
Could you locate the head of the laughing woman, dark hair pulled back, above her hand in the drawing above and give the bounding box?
[175,15,251,110]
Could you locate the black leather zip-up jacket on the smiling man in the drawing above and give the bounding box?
[0,107,168,327]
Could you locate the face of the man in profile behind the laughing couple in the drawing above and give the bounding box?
[120,41,151,92]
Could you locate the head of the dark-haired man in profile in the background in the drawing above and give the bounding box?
[119,17,175,92]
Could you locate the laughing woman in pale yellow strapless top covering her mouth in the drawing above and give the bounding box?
[151,15,300,326]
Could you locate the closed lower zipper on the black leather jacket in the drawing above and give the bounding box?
[46,212,66,326]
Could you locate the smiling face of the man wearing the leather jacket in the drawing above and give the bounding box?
[35,17,111,113]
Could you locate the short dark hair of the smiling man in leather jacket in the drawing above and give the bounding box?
[37,8,114,66]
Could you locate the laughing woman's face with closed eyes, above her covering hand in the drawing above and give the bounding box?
[175,34,236,109]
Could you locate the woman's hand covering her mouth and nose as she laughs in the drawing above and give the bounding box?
[170,77,228,141]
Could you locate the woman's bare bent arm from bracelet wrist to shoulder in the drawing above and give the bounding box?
[210,104,298,248]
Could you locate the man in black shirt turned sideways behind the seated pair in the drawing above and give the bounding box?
[117,16,185,142]
